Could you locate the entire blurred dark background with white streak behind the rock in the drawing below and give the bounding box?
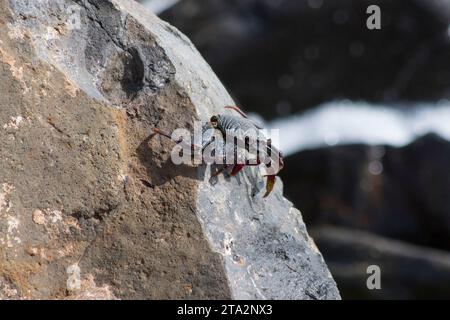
[141,0,450,299]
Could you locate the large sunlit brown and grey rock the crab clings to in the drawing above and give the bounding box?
[0,0,339,299]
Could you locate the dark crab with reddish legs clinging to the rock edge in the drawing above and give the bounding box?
[151,106,284,198]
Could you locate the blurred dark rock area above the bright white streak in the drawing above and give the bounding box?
[162,0,450,119]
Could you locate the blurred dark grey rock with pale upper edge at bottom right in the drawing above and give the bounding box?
[311,226,450,299]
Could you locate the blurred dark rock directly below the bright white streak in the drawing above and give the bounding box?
[282,135,450,250]
